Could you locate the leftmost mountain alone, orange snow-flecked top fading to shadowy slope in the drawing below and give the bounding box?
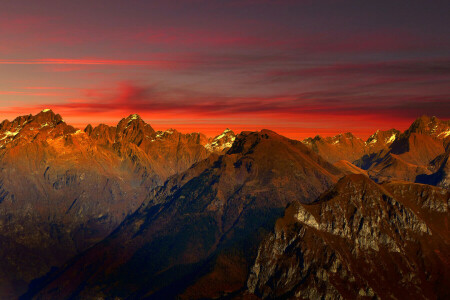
[0,110,158,298]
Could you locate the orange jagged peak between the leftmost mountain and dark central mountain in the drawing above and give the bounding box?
[85,114,214,186]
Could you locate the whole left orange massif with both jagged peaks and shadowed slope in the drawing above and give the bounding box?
[0,110,211,299]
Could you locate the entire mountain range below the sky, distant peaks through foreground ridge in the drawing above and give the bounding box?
[0,110,450,299]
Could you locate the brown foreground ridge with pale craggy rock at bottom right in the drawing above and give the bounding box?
[247,175,450,299]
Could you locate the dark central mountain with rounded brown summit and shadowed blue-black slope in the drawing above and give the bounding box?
[28,130,341,299]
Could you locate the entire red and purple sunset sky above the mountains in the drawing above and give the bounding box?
[0,0,450,138]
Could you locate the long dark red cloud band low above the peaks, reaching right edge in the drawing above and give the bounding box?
[29,82,450,120]
